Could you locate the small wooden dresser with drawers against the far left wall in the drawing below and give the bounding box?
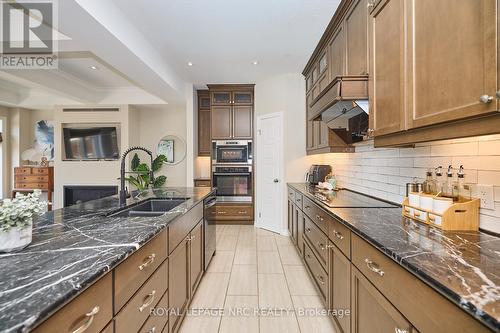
[12,166,54,210]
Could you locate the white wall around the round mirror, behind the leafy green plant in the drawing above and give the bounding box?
[137,105,189,186]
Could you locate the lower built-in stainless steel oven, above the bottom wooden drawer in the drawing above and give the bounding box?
[212,165,253,202]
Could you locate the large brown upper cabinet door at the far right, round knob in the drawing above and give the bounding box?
[407,0,497,128]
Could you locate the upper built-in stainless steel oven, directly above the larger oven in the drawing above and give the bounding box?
[212,140,252,164]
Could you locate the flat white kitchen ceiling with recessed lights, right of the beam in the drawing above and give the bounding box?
[112,0,340,85]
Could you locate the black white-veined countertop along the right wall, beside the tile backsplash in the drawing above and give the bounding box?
[288,184,500,331]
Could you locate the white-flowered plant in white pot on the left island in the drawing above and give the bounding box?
[0,190,47,252]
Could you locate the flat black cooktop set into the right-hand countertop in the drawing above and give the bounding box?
[308,187,399,208]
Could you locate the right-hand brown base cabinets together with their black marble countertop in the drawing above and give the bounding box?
[288,183,500,332]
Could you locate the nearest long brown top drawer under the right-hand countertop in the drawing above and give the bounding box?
[352,235,489,332]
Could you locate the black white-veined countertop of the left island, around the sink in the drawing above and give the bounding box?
[0,187,213,332]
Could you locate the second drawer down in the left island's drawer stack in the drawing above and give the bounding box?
[115,260,168,333]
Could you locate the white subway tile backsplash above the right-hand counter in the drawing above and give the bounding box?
[324,135,500,233]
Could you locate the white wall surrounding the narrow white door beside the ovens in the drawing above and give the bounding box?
[254,73,322,233]
